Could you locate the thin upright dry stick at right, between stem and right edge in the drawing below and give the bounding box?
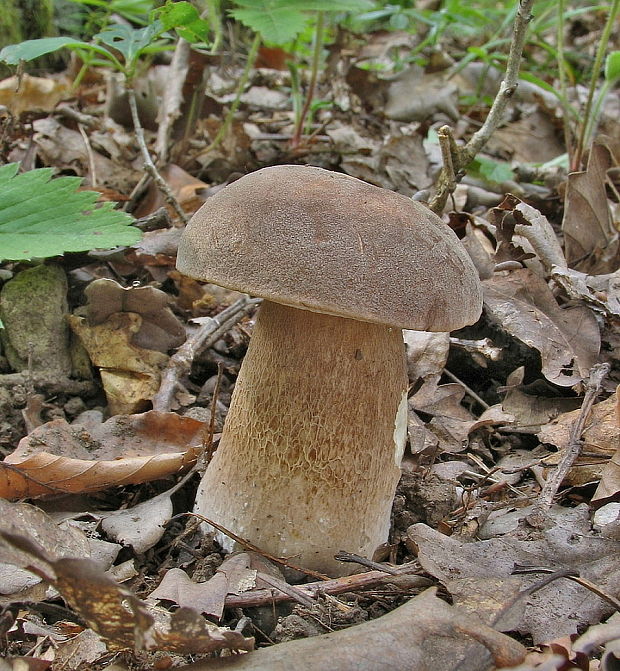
[536,363,610,513]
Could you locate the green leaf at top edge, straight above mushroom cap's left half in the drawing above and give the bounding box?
[231,0,309,44]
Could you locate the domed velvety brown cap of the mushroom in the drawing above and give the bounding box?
[177,165,482,331]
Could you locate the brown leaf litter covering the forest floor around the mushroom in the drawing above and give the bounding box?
[0,2,620,671]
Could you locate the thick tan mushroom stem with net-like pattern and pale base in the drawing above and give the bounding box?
[196,301,407,575]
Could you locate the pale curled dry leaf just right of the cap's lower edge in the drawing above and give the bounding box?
[483,268,600,387]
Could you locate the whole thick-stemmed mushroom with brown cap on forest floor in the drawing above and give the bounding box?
[177,165,482,575]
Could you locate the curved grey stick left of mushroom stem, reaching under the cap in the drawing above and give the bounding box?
[153,296,259,411]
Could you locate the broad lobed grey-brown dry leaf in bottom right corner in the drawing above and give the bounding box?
[407,505,620,643]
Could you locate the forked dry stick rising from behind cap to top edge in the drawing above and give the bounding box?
[429,0,534,214]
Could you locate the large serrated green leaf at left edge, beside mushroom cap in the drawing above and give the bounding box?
[0,163,141,261]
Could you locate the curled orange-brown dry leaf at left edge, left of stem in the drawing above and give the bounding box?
[0,410,204,498]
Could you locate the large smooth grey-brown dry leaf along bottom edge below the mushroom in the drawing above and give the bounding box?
[176,588,525,671]
